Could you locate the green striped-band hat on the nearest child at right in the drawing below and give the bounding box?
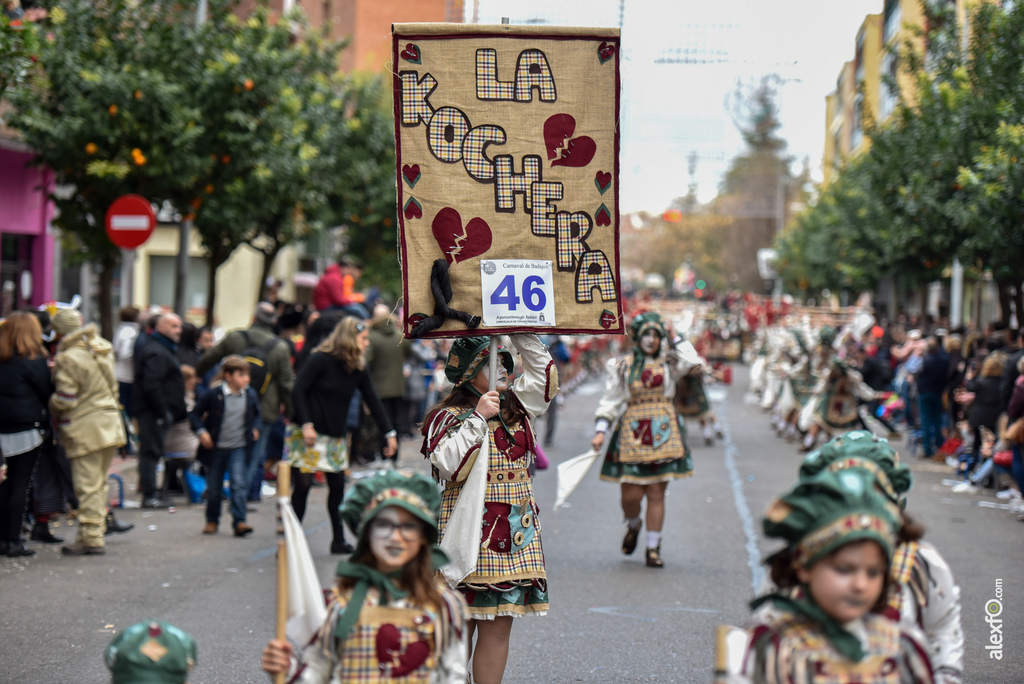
[763,469,901,567]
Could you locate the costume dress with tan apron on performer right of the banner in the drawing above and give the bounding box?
[597,342,700,484]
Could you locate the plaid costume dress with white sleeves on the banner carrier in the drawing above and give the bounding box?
[423,335,558,619]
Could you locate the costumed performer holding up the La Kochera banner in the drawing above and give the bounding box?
[422,335,558,684]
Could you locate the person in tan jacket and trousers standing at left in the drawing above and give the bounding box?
[50,309,126,556]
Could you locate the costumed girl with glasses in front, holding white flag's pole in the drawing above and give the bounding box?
[263,470,468,684]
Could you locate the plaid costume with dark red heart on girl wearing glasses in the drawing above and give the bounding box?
[288,581,467,684]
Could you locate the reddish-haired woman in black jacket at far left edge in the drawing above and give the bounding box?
[0,311,53,557]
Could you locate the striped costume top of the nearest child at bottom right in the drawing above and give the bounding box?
[742,612,934,684]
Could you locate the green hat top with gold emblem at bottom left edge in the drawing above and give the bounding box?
[103,619,196,684]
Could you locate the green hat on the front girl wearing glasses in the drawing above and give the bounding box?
[339,470,441,553]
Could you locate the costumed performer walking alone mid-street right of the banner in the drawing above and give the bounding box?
[591,311,701,567]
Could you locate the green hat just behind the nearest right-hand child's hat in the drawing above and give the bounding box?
[800,430,913,504]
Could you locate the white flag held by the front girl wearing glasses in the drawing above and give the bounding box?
[278,497,327,647]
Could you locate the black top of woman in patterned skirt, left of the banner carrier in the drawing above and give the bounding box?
[293,351,393,437]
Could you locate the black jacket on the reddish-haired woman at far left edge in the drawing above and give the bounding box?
[0,355,53,434]
